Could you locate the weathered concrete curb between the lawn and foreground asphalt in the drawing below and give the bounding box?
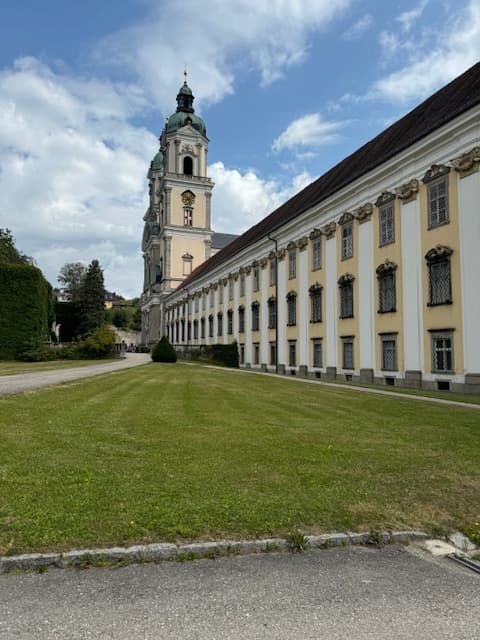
[0,530,428,573]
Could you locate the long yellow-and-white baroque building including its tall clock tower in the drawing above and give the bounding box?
[142,63,480,393]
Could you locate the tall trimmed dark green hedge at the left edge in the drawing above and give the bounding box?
[0,264,52,360]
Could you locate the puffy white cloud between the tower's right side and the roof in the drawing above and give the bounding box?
[209,162,312,233]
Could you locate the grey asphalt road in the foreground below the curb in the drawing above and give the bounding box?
[0,546,480,640]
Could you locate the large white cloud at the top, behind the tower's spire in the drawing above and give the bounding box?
[95,0,352,112]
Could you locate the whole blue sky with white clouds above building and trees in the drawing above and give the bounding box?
[0,0,480,297]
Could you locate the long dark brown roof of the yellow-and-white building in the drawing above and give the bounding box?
[178,62,480,289]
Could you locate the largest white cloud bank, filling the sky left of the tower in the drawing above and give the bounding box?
[0,58,157,295]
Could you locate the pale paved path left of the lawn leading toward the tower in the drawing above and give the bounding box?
[0,353,151,396]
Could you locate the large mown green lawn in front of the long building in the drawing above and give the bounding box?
[0,364,480,553]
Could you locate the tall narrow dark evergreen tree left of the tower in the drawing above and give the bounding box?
[78,260,105,335]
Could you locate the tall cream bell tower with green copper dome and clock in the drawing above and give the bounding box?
[141,71,213,344]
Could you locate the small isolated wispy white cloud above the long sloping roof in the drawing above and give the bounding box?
[272,113,347,151]
